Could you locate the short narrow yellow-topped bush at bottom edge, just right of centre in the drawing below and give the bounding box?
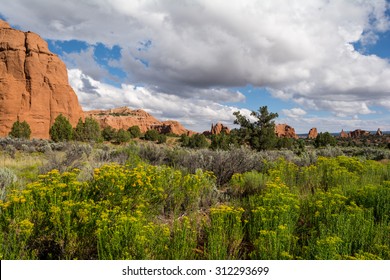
[206,204,244,260]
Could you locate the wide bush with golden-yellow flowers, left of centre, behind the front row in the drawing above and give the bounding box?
[91,163,215,216]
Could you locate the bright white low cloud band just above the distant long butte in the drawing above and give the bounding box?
[68,69,250,132]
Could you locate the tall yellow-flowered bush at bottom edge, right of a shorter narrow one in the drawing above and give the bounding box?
[248,178,300,259]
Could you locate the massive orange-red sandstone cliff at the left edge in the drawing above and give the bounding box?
[0,20,84,139]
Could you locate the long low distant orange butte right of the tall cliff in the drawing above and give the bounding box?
[84,107,195,136]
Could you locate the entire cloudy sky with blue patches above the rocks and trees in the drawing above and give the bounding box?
[0,0,390,133]
